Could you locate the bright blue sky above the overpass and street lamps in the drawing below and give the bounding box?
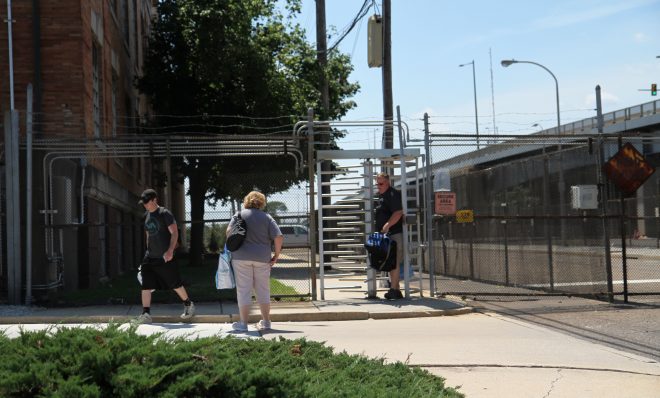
[299,0,660,149]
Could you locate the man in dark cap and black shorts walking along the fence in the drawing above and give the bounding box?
[134,189,195,324]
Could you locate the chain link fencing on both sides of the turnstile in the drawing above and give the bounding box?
[0,118,660,300]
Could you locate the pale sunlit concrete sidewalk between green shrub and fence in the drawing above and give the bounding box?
[0,278,660,398]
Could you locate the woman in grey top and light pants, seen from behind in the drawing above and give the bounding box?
[227,191,284,332]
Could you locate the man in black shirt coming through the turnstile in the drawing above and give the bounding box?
[376,173,403,300]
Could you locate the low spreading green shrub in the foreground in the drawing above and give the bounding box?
[0,325,462,398]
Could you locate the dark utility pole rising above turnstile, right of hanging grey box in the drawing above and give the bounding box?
[383,0,394,149]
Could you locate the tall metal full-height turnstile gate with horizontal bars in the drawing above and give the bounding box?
[316,149,423,300]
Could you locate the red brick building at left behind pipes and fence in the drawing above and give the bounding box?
[0,0,165,299]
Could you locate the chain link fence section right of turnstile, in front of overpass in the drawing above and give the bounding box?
[431,136,660,301]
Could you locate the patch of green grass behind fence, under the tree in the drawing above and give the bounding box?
[51,256,300,306]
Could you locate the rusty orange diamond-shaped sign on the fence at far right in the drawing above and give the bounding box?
[603,142,655,195]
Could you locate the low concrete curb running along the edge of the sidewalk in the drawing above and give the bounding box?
[0,307,473,325]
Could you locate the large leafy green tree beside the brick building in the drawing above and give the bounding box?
[138,0,359,265]
